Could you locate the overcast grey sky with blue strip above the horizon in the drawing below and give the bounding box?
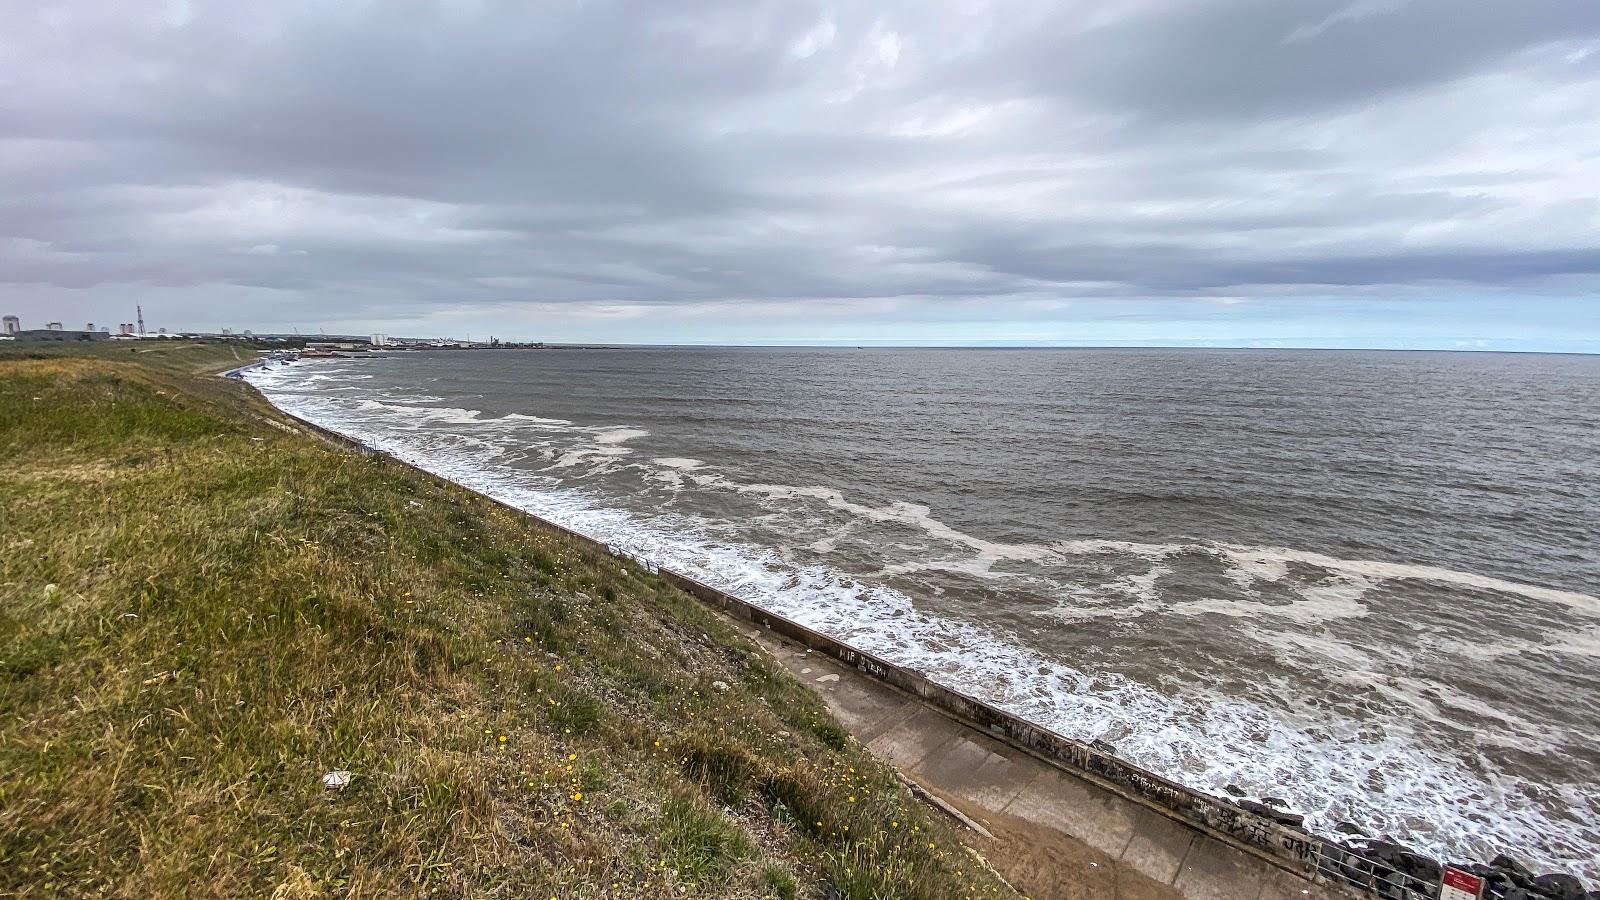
[0,0,1600,352]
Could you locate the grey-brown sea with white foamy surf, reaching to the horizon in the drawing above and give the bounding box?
[251,349,1600,878]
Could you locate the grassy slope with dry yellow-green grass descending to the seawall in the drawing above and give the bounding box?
[0,348,1006,897]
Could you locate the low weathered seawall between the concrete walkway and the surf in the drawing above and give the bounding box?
[243,387,1478,900]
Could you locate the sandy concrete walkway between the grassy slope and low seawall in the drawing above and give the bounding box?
[746,626,1350,900]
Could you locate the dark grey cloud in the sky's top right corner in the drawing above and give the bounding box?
[1016,0,1600,119]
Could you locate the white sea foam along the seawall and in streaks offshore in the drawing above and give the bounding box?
[240,358,1600,874]
